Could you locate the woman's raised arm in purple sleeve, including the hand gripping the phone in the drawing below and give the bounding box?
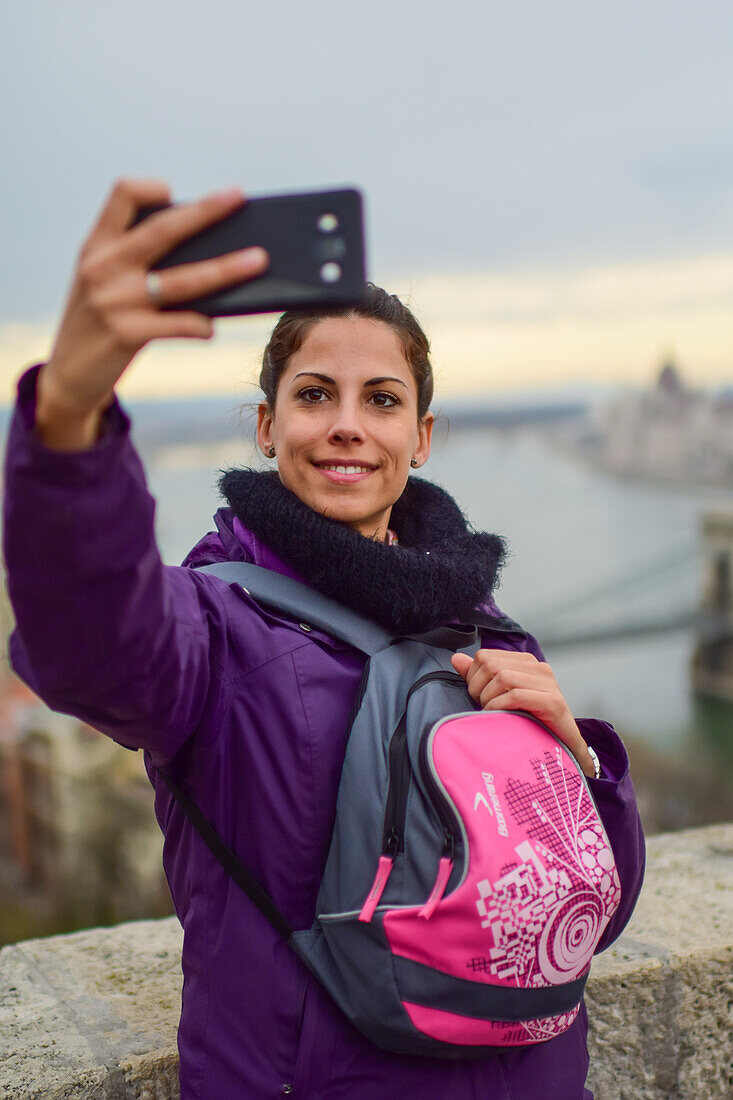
[3,183,268,763]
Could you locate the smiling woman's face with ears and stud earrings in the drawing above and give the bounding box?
[258,317,434,539]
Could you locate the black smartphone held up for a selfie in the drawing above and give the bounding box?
[134,188,367,317]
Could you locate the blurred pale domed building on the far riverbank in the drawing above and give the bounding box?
[576,361,733,486]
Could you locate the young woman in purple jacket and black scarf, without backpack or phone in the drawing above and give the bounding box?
[4,182,644,1100]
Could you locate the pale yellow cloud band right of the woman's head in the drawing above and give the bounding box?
[392,254,733,392]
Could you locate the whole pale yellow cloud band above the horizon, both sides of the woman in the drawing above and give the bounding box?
[0,254,733,400]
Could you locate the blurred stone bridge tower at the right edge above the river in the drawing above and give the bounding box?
[691,513,733,703]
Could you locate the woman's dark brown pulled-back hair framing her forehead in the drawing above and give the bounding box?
[260,283,433,420]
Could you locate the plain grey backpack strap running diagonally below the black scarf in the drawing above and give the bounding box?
[191,561,393,657]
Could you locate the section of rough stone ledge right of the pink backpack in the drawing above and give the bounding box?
[587,825,733,1100]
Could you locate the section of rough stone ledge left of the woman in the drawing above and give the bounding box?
[0,917,183,1100]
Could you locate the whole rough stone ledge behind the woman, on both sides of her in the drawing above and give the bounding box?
[0,824,733,1100]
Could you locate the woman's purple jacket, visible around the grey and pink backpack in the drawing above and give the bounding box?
[4,369,644,1100]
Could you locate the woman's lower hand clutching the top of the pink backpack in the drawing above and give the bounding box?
[450,649,595,778]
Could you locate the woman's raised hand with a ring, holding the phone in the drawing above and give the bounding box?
[36,180,269,449]
